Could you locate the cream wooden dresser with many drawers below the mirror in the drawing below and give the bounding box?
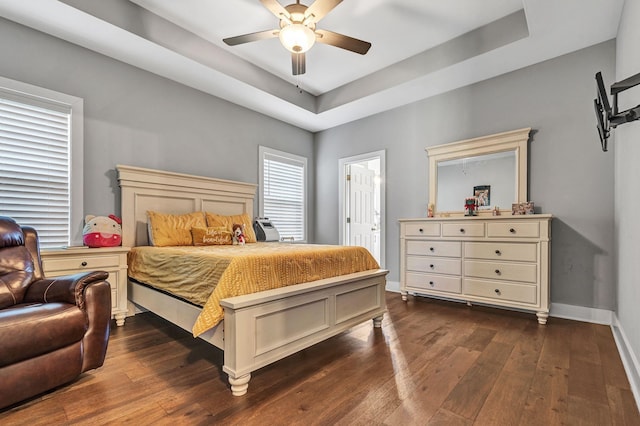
[399,214,552,324]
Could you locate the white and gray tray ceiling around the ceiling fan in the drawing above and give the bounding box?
[0,0,624,131]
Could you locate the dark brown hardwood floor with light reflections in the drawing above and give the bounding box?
[0,293,640,426]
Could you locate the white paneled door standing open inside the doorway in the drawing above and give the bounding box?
[347,164,377,254]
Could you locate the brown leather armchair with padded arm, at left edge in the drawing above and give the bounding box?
[0,216,111,409]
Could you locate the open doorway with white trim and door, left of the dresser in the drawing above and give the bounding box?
[339,151,385,267]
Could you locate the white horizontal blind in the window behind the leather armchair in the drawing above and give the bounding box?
[0,91,71,248]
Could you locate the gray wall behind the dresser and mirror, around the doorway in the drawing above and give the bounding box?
[315,41,615,309]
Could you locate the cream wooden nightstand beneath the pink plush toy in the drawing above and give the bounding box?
[41,247,129,326]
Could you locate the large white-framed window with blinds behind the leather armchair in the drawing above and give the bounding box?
[0,77,83,248]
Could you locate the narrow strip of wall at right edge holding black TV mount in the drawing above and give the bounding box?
[616,1,640,392]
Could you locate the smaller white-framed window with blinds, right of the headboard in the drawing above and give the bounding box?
[259,146,307,241]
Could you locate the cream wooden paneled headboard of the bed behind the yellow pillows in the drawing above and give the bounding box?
[116,165,257,247]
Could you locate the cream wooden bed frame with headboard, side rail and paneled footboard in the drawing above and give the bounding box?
[117,165,388,396]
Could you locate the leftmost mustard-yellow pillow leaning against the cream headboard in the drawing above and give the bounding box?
[147,211,207,247]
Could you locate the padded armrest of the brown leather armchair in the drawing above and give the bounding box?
[24,271,109,310]
